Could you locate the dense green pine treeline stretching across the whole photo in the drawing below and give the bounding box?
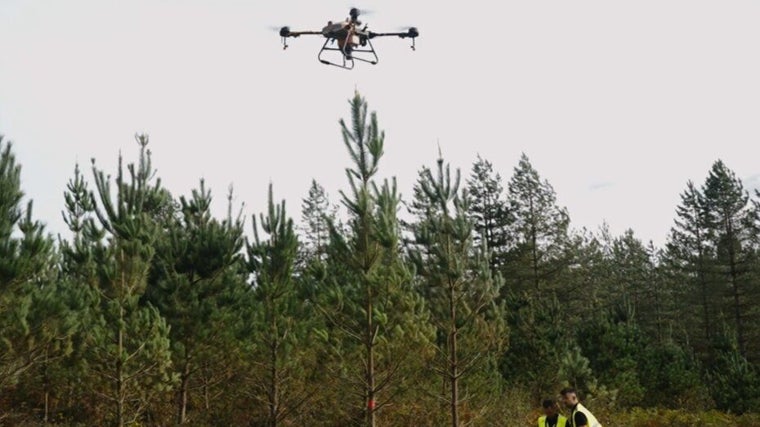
[0,94,760,426]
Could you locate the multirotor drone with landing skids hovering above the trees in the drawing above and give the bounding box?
[280,7,420,70]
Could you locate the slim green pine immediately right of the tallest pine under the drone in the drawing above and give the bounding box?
[411,155,505,427]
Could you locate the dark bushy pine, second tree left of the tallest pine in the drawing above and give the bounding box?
[145,180,245,424]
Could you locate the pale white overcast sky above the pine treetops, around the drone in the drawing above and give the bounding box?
[0,0,760,245]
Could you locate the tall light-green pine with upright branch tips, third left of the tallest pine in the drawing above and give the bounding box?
[86,135,173,426]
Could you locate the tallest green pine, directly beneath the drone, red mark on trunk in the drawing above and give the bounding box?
[321,93,425,427]
